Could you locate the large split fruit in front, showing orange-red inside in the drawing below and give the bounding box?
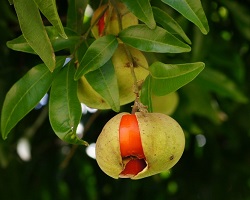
[96,112,185,179]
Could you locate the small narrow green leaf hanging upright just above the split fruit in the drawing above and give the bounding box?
[140,75,153,112]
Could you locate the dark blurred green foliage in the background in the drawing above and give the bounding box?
[0,0,250,200]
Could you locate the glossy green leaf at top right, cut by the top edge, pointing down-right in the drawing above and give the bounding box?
[162,0,209,34]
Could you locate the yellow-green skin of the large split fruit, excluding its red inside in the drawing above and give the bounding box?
[96,112,185,179]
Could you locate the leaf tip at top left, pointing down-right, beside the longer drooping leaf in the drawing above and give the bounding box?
[34,0,68,39]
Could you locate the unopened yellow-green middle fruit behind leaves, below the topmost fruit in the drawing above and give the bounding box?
[78,44,149,109]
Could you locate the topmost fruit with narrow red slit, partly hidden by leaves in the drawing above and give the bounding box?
[91,3,138,38]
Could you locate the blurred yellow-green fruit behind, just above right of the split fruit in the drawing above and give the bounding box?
[152,92,179,115]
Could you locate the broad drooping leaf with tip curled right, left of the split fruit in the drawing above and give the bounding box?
[49,62,87,145]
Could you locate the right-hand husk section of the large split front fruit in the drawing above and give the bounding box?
[132,112,185,179]
